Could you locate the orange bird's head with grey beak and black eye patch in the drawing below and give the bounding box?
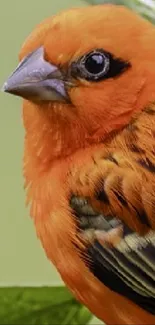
[3,5,155,161]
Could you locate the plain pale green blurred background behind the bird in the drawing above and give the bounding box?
[0,0,155,324]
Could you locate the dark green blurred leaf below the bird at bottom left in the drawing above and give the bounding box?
[0,287,92,325]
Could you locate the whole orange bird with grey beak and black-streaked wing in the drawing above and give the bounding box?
[3,5,155,325]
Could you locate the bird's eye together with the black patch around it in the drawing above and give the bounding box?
[70,49,130,81]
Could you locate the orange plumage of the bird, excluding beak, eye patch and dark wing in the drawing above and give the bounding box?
[3,5,155,324]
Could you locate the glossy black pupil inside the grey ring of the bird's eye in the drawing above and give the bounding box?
[85,54,104,74]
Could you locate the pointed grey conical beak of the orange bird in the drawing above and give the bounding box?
[2,47,69,101]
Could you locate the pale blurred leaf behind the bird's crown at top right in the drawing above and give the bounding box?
[86,0,155,24]
